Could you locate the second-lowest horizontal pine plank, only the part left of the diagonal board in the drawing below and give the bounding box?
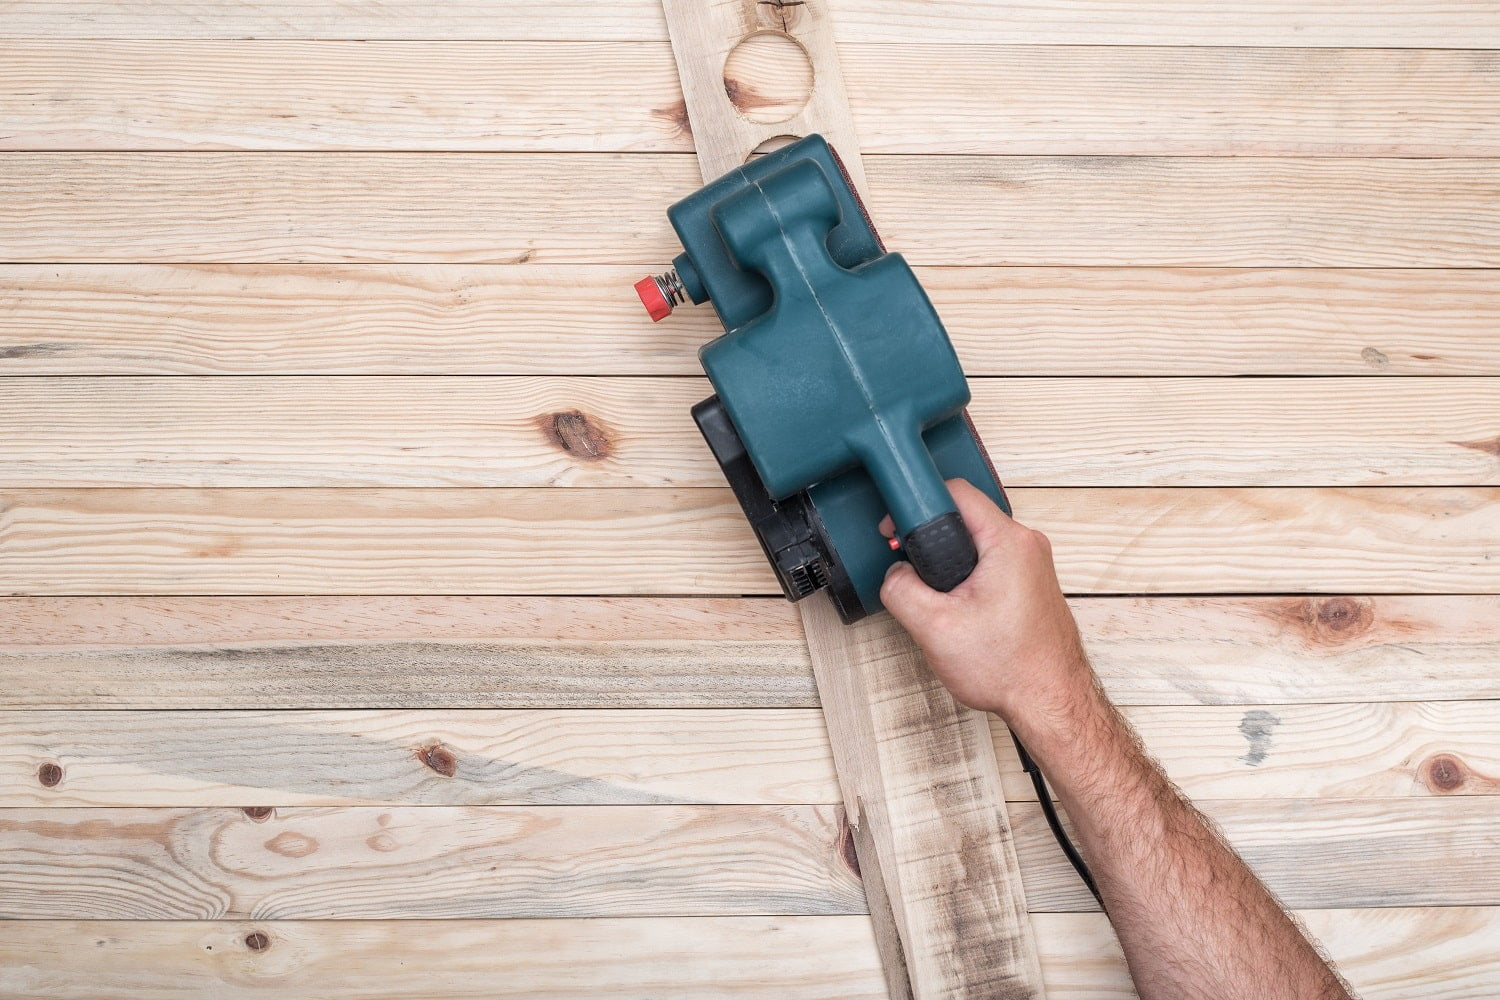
[0,805,864,921]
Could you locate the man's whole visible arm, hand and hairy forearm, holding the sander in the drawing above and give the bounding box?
[881,480,1350,1000]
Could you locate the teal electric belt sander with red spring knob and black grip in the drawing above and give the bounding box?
[636,135,1010,622]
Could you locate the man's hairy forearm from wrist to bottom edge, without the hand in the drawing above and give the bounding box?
[1014,671,1350,1000]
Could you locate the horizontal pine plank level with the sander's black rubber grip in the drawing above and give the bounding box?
[0,487,1500,597]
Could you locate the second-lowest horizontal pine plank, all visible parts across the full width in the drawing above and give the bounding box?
[0,796,1500,919]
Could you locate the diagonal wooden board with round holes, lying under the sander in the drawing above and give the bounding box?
[662,0,1046,1000]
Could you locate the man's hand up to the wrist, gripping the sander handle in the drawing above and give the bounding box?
[881,480,1094,723]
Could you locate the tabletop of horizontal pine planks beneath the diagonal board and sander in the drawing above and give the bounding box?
[0,0,1500,1000]
